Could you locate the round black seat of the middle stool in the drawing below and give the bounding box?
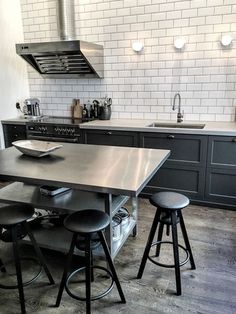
[64,209,110,234]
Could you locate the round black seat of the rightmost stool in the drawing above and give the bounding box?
[150,192,189,210]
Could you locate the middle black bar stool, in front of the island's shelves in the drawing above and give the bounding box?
[56,209,126,314]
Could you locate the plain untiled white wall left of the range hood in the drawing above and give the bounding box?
[0,0,29,148]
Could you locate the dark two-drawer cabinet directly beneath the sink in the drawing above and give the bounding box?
[140,133,207,200]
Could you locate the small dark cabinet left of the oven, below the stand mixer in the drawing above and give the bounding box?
[2,124,26,148]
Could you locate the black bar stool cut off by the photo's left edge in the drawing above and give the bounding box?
[0,204,54,313]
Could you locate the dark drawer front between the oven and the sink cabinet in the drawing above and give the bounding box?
[84,130,138,147]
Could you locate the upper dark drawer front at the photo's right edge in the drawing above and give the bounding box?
[207,136,236,169]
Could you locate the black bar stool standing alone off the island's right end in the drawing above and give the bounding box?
[137,192,196,295]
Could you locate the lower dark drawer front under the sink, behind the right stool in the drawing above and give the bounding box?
[142,165,205,200]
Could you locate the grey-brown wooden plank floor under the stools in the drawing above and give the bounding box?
[0,199,236,314]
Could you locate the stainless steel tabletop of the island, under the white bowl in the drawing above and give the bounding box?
[0,143,170,196]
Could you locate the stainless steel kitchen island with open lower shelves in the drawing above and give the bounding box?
[0,143,170,258]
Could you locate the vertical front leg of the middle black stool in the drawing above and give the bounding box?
[85,236,91,314]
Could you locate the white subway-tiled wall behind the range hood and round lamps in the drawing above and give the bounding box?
[21,0,236,121]
